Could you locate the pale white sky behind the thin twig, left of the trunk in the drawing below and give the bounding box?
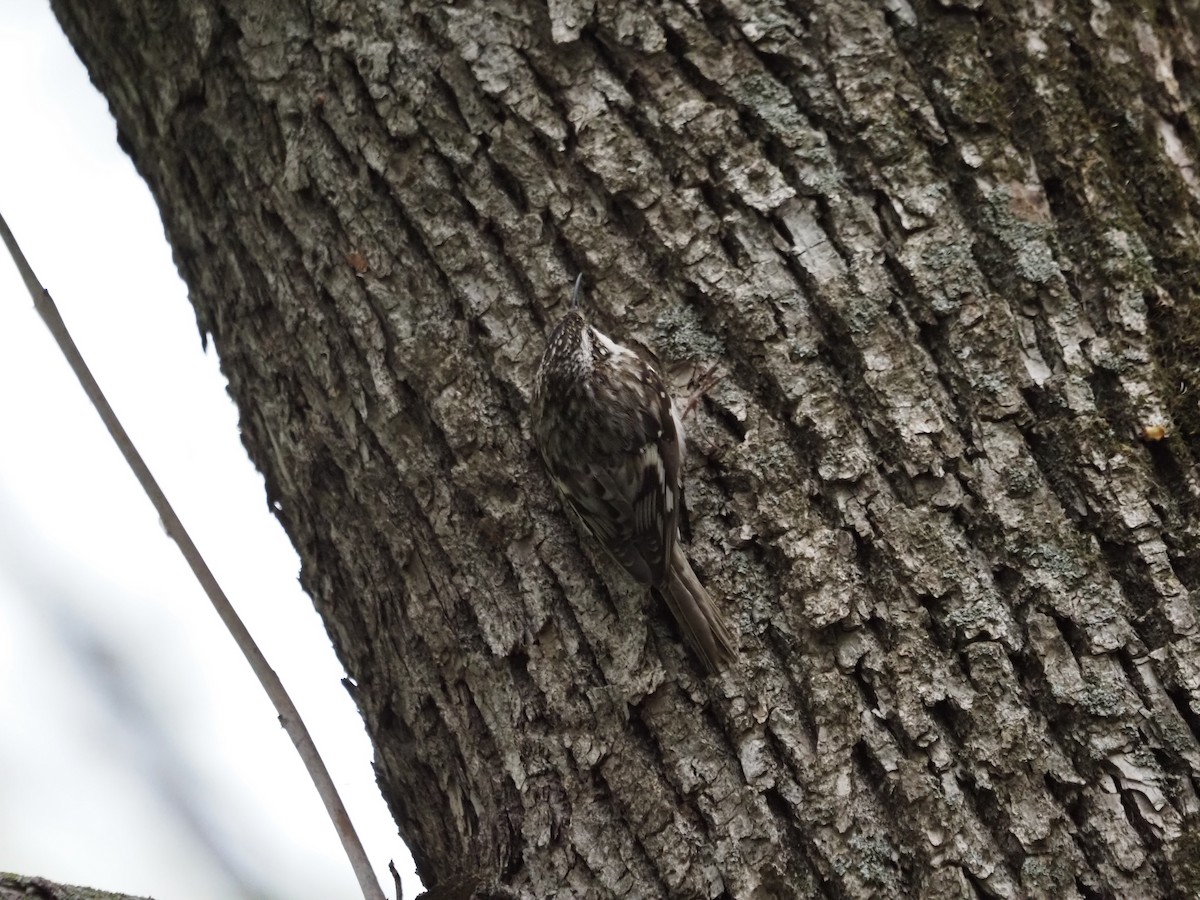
[0,0,420,900]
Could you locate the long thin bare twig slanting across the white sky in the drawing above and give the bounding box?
[0,216,384,900]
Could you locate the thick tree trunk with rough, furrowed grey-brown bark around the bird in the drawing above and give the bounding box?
[54,0,1200,898]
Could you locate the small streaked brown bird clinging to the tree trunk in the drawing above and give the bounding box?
[533,275,736,672]
